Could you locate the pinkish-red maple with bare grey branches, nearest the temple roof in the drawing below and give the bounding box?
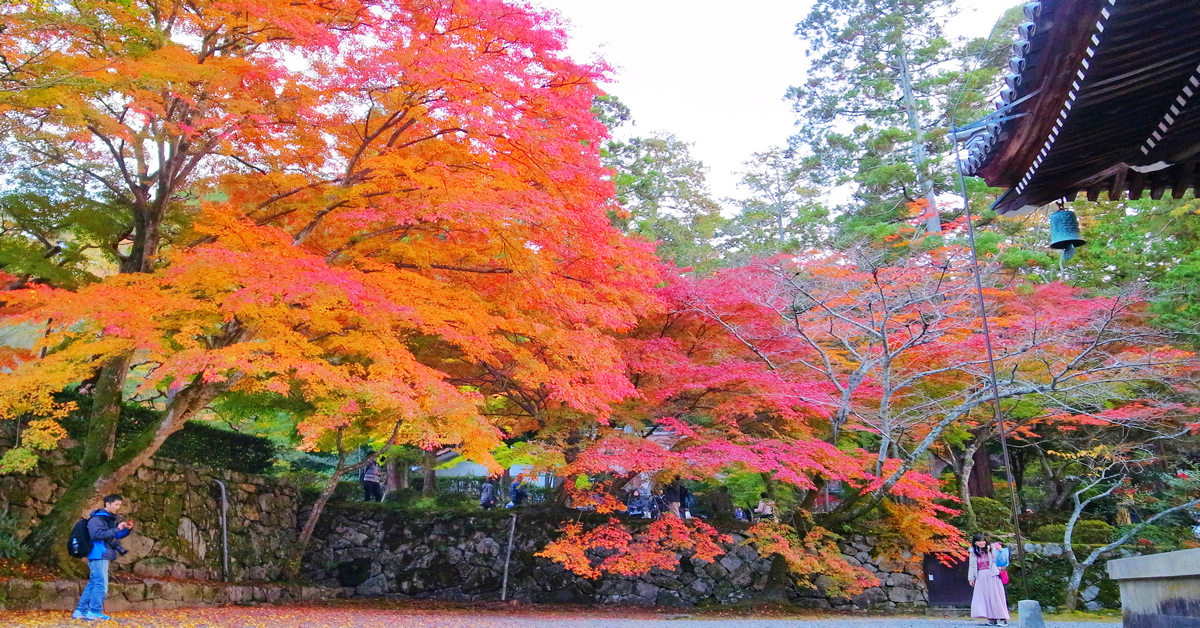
[537,213,1196,592]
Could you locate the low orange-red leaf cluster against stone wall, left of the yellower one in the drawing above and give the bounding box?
[536,515,732,579]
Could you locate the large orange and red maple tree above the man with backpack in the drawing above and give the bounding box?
[0,1,656,571]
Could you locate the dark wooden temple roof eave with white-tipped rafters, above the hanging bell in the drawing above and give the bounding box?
[958,0,1200,214]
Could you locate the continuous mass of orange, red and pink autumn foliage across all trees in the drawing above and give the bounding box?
[0,0,1194,594]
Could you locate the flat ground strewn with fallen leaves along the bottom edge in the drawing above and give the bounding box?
[0,606,1120,628]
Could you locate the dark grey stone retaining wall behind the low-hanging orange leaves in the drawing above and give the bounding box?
[304,504,926,609]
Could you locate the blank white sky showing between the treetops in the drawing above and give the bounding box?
[529,0,1018,205]
